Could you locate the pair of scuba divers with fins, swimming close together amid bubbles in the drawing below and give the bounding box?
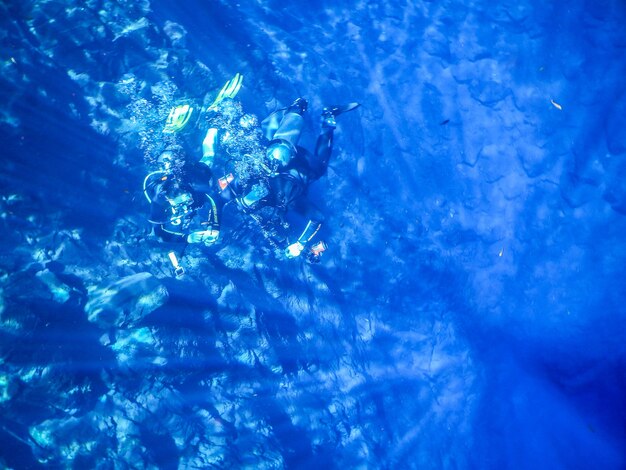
[143,74,359,275]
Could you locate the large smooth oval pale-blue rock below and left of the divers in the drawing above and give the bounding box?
[85,273,168,328]
